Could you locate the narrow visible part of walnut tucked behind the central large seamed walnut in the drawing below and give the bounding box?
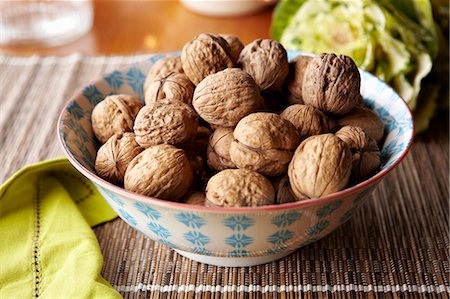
[206,128,236,171]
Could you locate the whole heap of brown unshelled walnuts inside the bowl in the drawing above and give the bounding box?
[92,34,384,207]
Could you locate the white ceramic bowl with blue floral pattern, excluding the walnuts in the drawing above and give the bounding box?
[58,52,414,266]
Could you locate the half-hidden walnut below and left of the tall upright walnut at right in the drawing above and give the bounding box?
[280,104,329,139]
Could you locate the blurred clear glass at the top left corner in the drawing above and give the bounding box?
[0,0,93,46]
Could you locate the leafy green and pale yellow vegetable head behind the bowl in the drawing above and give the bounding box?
[272,0,439,132]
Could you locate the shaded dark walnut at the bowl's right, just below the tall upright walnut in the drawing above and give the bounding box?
[336,105,384,142]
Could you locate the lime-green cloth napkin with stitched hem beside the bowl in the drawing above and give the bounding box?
[0,159,121,298]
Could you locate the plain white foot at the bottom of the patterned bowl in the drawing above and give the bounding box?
[175,249,295,267]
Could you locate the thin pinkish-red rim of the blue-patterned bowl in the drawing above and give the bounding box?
[56,50,415,214]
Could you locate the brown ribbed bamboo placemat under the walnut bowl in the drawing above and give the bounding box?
[0,54,450,298]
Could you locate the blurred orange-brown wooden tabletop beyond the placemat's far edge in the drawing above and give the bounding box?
[0,0,273,55]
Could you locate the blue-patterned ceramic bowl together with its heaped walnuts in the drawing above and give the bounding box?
[58,34,414,266]
